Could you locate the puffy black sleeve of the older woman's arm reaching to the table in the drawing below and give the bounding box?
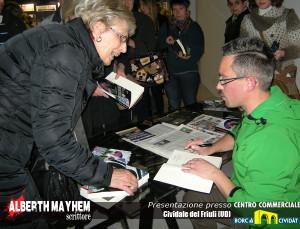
[30,44,112,187]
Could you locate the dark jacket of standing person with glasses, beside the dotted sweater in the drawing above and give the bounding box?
[224,8,250,43]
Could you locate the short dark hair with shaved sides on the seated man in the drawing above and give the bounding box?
[222,37,275,91]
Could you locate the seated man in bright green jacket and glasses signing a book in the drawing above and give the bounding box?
[183,38,300,229]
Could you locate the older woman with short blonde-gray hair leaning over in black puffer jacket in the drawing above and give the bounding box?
[0,0,138,228]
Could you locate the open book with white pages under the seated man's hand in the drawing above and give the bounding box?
[154,150,222,193]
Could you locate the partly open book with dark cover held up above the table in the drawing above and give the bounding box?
[98,72,144,109]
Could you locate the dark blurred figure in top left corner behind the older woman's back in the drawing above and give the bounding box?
[0,0,26,45]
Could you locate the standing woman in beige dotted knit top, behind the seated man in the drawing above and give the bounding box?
[240,0,300,72]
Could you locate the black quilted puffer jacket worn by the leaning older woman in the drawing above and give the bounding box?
[0,18,112,201]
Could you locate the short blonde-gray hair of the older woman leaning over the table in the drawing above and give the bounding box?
[75,0,136,36]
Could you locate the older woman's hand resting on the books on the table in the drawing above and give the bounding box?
[109,169,138,196]
